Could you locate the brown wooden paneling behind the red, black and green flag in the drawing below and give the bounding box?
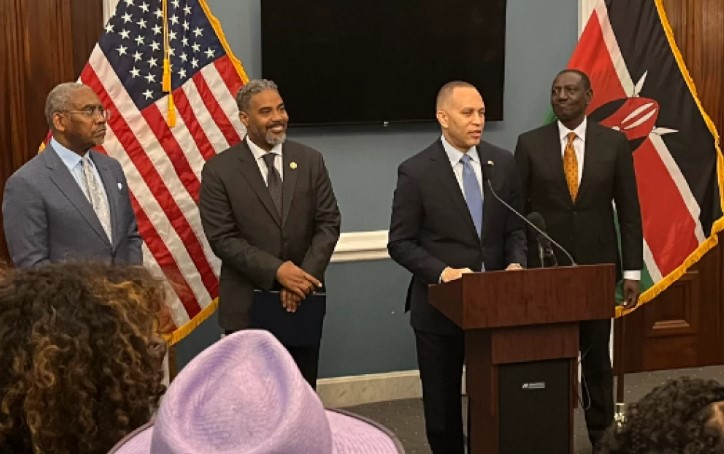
[623,0,724,372]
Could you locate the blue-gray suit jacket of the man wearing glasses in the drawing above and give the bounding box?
[3,145,143,267]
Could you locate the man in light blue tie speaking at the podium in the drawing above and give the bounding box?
[387,82,526,454]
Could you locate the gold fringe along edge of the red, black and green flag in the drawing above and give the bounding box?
[616,0,724,318]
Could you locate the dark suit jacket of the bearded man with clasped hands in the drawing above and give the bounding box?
[199,140,340,330]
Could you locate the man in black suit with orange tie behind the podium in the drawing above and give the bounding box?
[515,70,643,444]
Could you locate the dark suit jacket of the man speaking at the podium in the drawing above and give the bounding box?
[387,140,526,334]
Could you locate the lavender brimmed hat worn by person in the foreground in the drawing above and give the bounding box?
[111,330,404,454]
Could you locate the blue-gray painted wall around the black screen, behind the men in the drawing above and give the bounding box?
[177,0,578,377]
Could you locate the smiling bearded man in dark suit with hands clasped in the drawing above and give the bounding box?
[199,80,340,387]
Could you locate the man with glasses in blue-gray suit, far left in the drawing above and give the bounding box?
[2,82,142,267]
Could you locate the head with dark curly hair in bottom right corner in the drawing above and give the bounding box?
[597,377,724,454]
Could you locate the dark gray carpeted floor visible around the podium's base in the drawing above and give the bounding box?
[346,366,724,454]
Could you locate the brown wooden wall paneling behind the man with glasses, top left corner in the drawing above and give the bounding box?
[0,0,103,260]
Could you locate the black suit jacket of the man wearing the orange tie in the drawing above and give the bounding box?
[515,119,643,277]
